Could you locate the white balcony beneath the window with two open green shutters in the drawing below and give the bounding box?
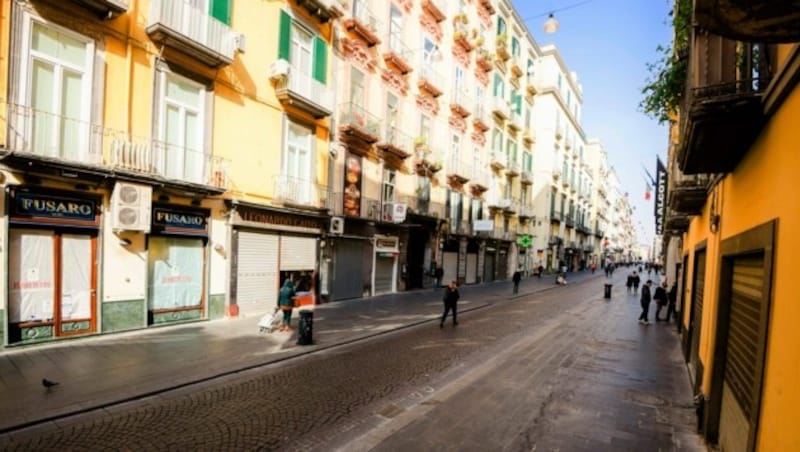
[275,66,333,119]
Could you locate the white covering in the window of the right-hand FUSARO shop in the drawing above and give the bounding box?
[148,237,203,309]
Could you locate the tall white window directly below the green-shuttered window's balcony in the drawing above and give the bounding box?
[276,121,314,204]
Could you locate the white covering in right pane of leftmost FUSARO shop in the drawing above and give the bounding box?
[61,235,92,320]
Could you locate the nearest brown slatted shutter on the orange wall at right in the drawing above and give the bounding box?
[720,255,765,450]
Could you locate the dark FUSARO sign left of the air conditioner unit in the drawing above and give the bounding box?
[10,190,99,227]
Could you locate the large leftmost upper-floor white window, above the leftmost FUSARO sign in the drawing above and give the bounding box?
[20,19,94,160]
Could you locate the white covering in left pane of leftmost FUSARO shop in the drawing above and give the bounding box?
[8,230,56,323]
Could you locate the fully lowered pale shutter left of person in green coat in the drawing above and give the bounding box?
[236,231,278,312]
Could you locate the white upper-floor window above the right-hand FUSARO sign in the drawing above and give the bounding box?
[157,71,207,184]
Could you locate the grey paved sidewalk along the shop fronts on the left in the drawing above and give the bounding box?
[0,271,608,434]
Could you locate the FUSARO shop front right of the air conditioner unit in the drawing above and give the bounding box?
[147,204,209,325]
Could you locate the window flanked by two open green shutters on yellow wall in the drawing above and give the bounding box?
[278,10,328,83]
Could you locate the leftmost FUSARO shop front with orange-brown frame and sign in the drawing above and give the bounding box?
[6,186,102,344]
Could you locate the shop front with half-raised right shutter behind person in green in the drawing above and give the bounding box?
[228,203,324,317]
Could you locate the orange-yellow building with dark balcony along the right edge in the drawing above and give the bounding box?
[666,2,800,451]
